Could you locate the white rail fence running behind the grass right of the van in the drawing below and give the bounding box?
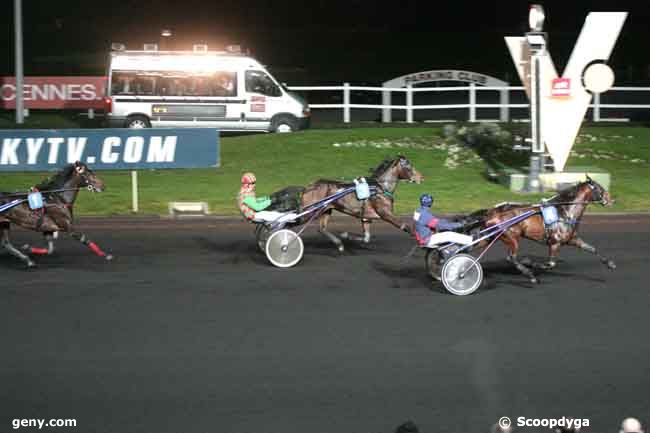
[289,83,650,123]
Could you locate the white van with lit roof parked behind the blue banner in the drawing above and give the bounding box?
[104,46,310,132]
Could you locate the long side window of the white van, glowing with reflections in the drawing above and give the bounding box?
[111,71,237,97]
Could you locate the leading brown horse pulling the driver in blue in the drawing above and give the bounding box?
[472,176,616,283]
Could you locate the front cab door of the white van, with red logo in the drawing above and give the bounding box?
[244,69,284,131]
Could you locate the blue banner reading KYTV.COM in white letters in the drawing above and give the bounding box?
[0,128,219,172]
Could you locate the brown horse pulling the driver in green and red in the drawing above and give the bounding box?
[301,155,424,251]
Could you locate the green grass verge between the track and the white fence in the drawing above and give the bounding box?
[0,126,650,215]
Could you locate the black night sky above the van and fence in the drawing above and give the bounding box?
[0,0,650,85]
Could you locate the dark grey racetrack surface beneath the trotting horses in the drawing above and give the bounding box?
[0,216,650,433]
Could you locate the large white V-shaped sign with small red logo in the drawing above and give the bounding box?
[505,12,627,171]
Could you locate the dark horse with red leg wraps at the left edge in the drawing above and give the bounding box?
[0,162,113,268]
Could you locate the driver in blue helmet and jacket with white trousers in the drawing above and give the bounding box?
[413,194,473,247]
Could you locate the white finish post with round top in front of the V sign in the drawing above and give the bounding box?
[526,5,548,192]
